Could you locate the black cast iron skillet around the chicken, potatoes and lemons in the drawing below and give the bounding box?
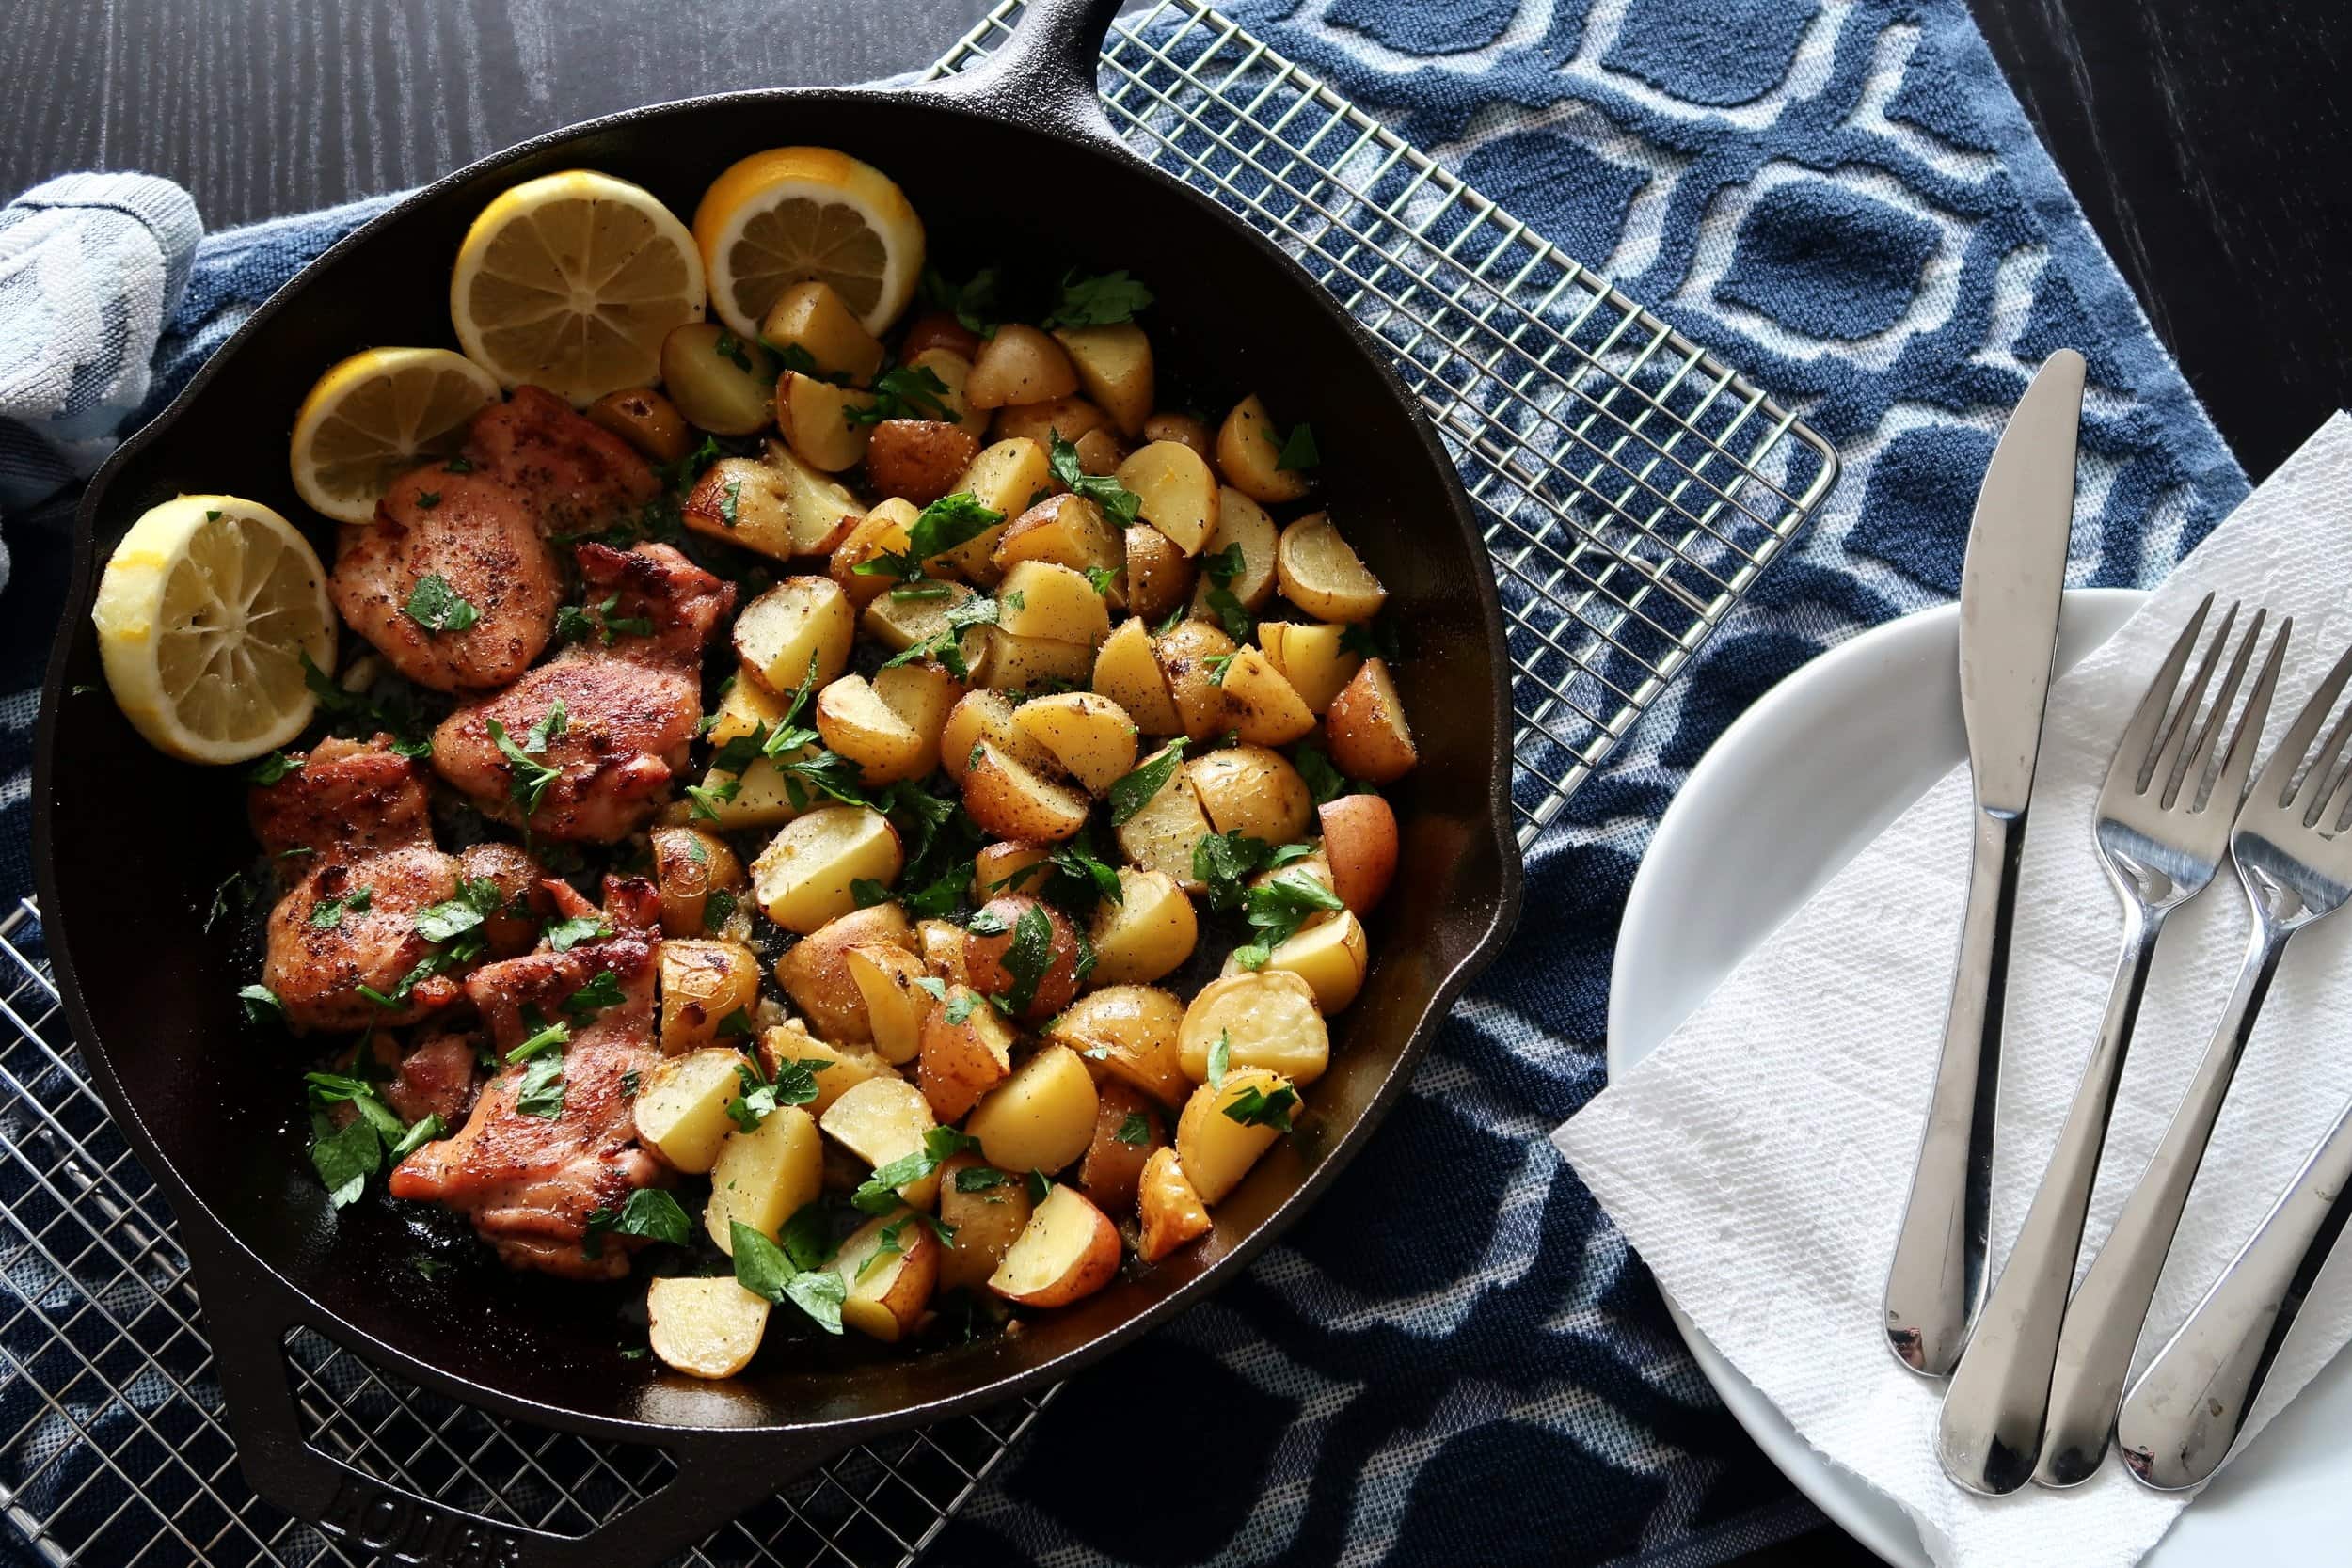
[33,0,1519,1568]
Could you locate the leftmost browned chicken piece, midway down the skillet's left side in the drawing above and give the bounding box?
[252,736,459,1030]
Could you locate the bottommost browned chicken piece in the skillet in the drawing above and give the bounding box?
[390,883,666,1279]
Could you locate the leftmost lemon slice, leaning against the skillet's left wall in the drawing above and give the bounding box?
[89,496,334,762]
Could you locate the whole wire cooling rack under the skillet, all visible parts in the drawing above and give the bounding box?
[0,0,1837,1568]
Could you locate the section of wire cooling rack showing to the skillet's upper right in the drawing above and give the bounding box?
[931,0,1837,844]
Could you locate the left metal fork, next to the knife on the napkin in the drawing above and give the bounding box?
[1936,594,2294,1496]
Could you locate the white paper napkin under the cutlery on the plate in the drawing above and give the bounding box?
[1555,414,2352,1568]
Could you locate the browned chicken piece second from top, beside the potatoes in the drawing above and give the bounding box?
[433,546,734,844]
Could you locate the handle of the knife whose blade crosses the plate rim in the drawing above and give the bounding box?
[1886,806,2026,1378]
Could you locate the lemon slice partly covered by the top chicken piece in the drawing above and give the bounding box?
[292,348,499,522]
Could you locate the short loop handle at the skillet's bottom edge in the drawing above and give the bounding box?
[198,1243,847,1568]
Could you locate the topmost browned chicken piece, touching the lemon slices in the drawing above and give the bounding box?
[329,386,661,691]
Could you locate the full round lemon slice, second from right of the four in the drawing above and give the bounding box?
[450,169,704,406]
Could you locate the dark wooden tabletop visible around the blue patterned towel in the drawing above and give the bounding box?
[0,0,2352,1568]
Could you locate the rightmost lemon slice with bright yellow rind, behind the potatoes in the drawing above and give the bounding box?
[694,148,922,336]
